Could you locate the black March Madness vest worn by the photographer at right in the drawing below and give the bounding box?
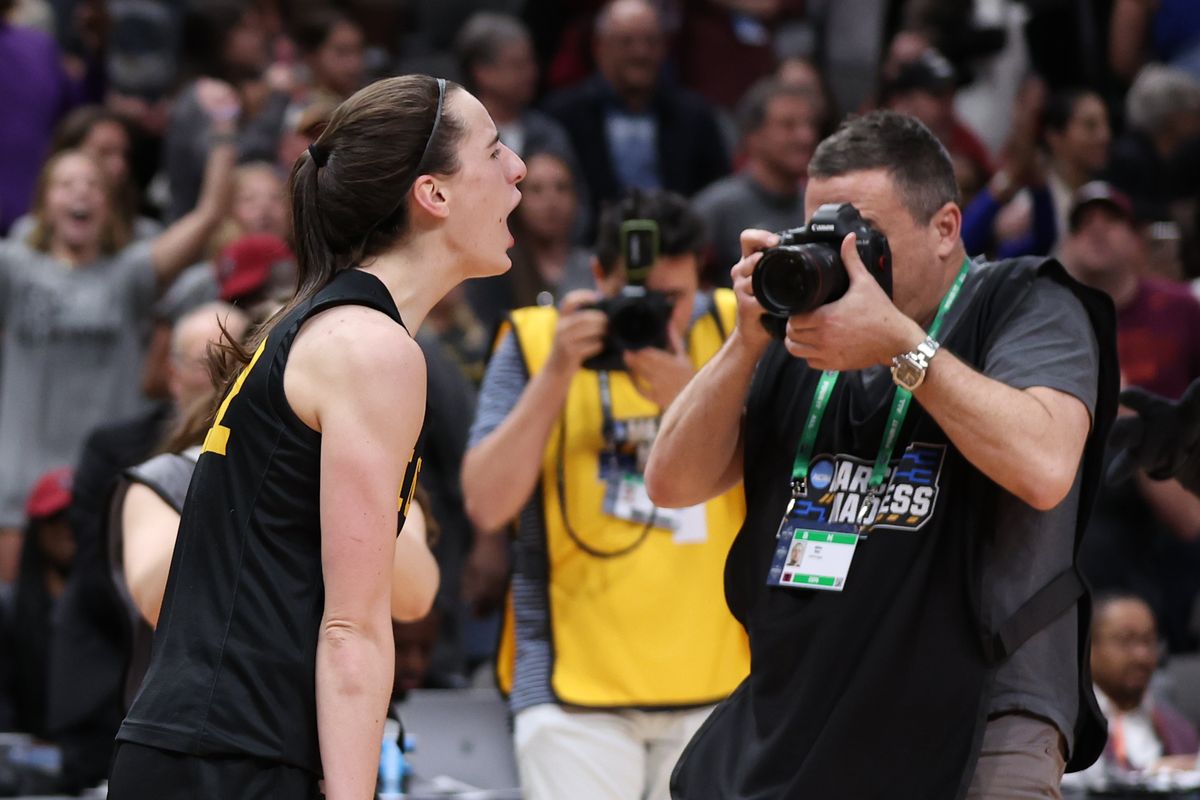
[672,259,1118,800]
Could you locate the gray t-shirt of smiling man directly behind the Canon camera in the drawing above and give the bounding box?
[691,173,804,285]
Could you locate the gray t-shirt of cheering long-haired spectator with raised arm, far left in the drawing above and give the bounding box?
[0,241,157,527]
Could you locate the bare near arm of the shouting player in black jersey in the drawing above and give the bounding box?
[300,307,436,800]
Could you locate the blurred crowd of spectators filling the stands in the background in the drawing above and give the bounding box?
[0,0,1200,789]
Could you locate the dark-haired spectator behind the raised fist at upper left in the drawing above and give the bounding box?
[162,0,290,221]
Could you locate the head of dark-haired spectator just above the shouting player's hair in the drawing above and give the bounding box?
[293,7,366,106]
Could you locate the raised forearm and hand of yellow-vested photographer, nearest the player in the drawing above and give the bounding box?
[462,290,607,534]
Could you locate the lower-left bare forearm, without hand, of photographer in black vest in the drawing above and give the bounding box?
[646,330,760,509]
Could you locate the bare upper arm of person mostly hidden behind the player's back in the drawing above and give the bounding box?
[121,483,179,627]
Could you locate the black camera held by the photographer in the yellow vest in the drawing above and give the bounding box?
[583,219,674,371]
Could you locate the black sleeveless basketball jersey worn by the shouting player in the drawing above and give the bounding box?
[118,270,424,775]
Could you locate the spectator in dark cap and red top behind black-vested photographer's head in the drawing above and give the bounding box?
[882,48,992,198]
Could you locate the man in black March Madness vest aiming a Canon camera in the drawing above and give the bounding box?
[646,112,1117,800]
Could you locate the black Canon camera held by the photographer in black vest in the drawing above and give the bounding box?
[750,203,892,326]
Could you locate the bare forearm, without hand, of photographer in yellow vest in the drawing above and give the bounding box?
[462,366,574,534]
